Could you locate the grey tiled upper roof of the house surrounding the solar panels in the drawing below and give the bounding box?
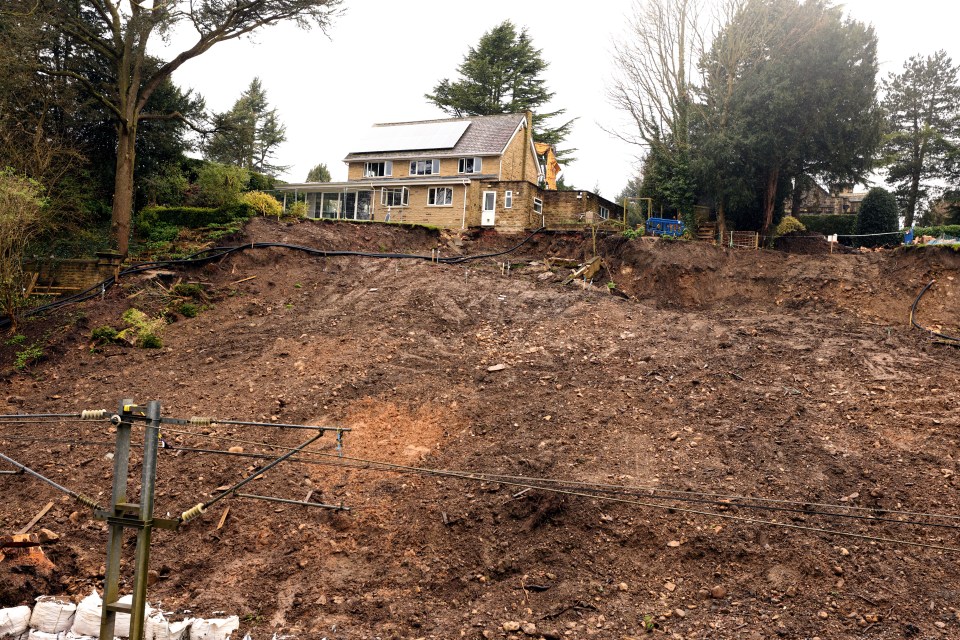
[343,113,526,162]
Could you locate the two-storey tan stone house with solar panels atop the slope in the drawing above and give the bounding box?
[282,114,623,231]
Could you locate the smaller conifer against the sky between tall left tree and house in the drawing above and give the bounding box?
[206,78,287,174]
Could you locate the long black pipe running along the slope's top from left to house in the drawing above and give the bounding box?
[0,227,546,328]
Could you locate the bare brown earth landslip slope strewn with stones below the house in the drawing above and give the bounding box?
[0,219,960,640]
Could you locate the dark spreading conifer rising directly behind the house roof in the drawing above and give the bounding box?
[424,20,576,163]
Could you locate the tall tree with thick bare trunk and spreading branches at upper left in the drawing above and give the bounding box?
[11,0,341,253]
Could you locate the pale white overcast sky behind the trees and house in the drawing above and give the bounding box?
[155,0,960,198]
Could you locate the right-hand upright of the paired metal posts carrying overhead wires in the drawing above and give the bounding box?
[128,400,160,640]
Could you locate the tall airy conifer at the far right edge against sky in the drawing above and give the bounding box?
[883,50,960,227]
